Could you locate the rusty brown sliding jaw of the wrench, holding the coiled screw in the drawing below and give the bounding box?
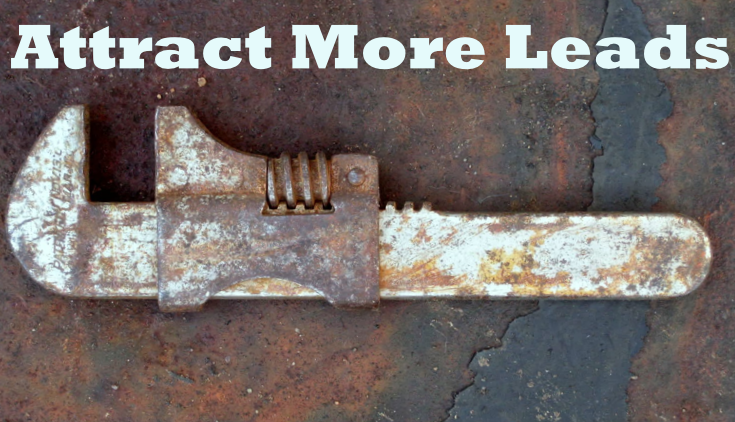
[157,107,380,311]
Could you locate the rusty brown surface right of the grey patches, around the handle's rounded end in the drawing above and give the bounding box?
[629,0,735,422]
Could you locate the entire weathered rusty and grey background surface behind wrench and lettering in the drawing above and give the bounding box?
[0,0,735,421]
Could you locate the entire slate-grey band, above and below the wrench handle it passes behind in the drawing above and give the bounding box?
[450,0,672,421]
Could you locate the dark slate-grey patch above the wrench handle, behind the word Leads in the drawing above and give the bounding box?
[589,0,672,211]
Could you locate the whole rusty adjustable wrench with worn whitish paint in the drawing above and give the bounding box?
[8,106,711,311]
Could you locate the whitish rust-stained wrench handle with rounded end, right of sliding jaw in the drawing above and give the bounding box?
[380,208,711,299]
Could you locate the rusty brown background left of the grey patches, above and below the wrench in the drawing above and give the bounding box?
[0,1,604,421]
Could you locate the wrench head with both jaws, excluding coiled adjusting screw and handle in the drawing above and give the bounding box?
[7,106,379,311]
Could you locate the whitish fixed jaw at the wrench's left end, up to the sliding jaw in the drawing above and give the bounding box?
[7,105,156,297]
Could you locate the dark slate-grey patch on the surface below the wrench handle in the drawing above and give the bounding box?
[448,301,648,422]
